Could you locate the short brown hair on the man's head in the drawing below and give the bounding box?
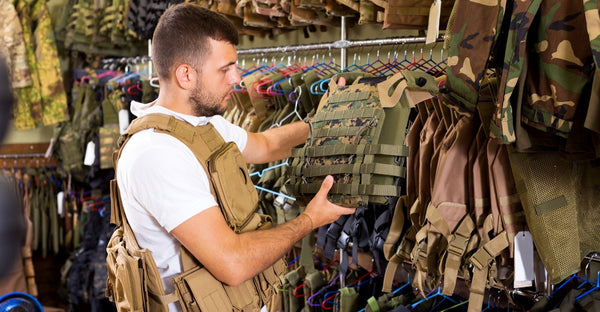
[152,3,239,80]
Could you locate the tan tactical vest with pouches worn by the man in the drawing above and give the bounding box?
[106,114,286,312]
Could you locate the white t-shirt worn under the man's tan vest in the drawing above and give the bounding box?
[116,101,248,311]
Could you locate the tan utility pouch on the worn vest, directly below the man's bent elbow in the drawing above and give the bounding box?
[173,267,260,312]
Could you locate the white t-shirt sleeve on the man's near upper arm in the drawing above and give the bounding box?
[119,134,217,232]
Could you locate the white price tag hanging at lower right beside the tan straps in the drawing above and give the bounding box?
[514,231,535,288]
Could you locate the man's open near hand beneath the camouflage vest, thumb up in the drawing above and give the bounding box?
[304,175,356,228]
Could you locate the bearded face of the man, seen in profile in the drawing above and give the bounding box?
[190,38,241,117]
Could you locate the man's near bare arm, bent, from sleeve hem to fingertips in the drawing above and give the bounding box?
[171,177,355,286]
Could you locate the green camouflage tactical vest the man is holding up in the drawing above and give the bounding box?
[289,72,418,208]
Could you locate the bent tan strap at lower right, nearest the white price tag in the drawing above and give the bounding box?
[468,231,509,312]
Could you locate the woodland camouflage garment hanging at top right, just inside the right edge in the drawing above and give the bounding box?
[491,0,593,143]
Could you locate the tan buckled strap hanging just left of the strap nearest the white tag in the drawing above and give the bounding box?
[442,215,475,296]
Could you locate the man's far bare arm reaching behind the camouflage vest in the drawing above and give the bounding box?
[242,121,309,164]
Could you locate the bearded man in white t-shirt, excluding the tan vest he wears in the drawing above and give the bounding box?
[116,4,354,310]
